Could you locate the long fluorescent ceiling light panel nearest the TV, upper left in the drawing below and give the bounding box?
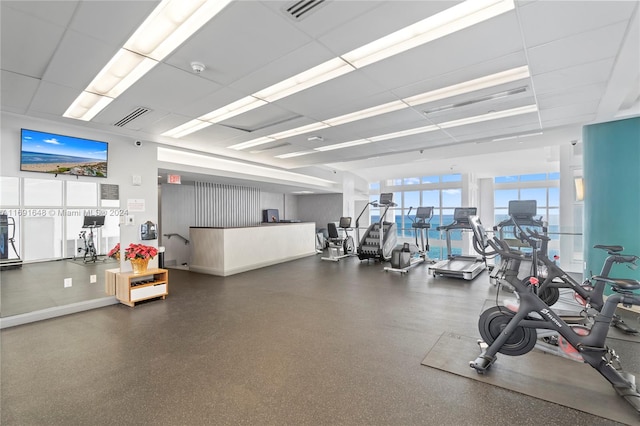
[63,0,231,120]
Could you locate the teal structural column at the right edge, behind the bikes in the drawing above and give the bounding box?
[582,117,640,292]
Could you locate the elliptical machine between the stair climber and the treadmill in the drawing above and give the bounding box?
[384,207,433,274]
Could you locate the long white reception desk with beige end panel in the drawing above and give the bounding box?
[189,222,316,277]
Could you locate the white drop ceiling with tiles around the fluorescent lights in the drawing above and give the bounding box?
[0,0,640,193]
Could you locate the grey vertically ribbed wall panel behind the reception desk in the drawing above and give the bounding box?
[195,182,261,228]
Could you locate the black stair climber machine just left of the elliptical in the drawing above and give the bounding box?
[356,192,398,262]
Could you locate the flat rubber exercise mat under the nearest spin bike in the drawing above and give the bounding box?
[422,333,640,425]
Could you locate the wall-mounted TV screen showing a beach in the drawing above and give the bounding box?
[20,129,109,178]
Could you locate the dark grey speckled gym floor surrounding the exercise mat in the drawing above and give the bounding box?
[0,257,636,425]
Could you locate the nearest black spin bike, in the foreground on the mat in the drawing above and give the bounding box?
[469,216,640,414]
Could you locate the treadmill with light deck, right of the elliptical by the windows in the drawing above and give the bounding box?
[429,207,487,280]
